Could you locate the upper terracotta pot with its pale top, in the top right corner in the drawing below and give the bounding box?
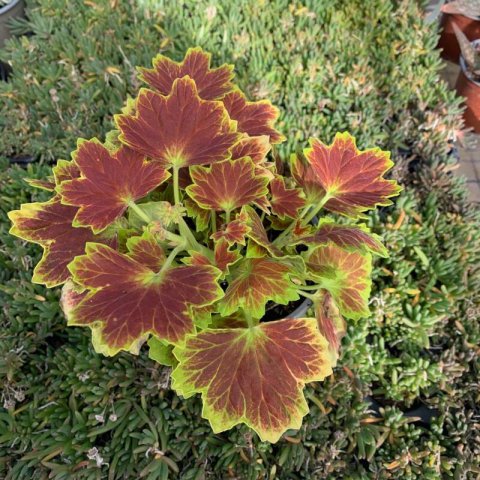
[438,0,480,63]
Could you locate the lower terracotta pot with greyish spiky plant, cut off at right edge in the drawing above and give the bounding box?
[454,25,480,133]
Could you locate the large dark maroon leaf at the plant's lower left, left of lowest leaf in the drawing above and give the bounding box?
[69,239,223,355]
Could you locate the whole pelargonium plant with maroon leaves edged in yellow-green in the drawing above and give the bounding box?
[10,48,399,442]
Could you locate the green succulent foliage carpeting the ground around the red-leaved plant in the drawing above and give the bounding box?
[0,0,480,480]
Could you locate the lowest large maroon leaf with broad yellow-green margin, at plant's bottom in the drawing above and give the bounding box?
[172,318,332,442]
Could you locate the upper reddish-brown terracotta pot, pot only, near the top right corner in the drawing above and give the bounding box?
[438,13,480,63]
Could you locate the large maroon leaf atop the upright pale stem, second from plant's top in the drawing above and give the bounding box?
[115,77,239,168]
